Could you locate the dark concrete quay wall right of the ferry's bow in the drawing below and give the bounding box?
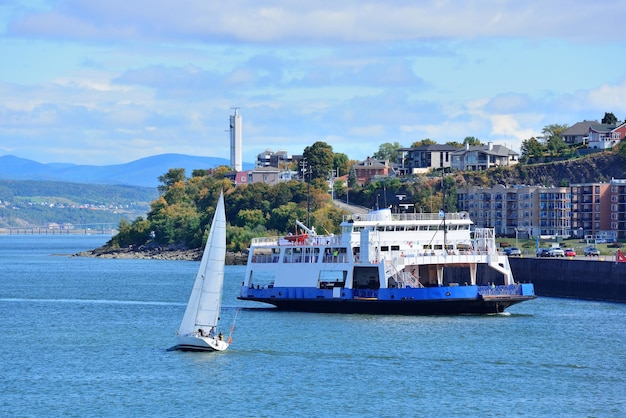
[509,257,626,302]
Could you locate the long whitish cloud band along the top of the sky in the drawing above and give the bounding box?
[9,0,626,44]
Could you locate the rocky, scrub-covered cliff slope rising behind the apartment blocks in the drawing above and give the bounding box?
[465,152,626,186]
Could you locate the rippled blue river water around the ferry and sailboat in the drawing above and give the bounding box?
[0,236,626,417]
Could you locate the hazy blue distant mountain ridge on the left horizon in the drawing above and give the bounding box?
[0,154,253,187]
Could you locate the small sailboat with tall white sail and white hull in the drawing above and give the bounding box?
[173,191,230,351]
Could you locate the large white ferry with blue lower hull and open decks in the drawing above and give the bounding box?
[238,209,536,315]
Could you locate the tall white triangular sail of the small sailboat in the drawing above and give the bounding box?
[178,192,226,336]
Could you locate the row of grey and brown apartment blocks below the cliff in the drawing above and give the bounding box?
[457,179,626,241]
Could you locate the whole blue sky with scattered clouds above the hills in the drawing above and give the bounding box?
[0,0,626,165]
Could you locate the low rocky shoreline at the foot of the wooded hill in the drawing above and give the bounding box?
[74,246,248,265]
